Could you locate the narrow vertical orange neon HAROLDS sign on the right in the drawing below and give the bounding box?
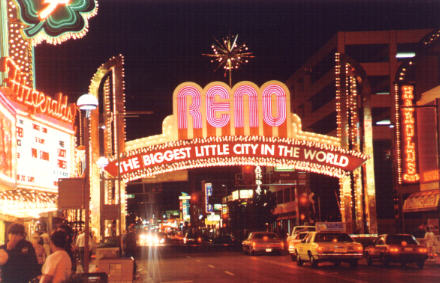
[401,85,420,182]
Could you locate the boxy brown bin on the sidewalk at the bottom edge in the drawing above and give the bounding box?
[98,257,134,283]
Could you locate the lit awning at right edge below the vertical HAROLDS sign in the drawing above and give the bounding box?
[403,190,440,212]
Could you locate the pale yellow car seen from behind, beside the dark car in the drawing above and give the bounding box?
[296,231,363,267]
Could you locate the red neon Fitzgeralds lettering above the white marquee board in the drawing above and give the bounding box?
[0,58,76,124]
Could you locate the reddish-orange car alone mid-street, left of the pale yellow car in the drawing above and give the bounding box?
[241,232,284,255]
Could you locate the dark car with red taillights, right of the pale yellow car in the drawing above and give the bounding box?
[365,234,428,269]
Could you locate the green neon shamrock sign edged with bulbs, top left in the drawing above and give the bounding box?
[15,0,98,45]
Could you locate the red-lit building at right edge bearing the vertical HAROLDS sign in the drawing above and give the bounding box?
[395,30,440,235]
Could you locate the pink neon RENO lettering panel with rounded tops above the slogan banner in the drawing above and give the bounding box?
[174,81,290,139]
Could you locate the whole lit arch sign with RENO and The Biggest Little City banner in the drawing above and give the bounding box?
[106,81,367,181]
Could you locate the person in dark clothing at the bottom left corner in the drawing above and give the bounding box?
[0,223,40,283]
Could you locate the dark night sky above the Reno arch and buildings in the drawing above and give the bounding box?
[35,0,440,140]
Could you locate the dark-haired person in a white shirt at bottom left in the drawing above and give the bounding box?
[40,230,72,283]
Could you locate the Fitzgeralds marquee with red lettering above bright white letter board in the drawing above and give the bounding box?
[0,58,80,243]
